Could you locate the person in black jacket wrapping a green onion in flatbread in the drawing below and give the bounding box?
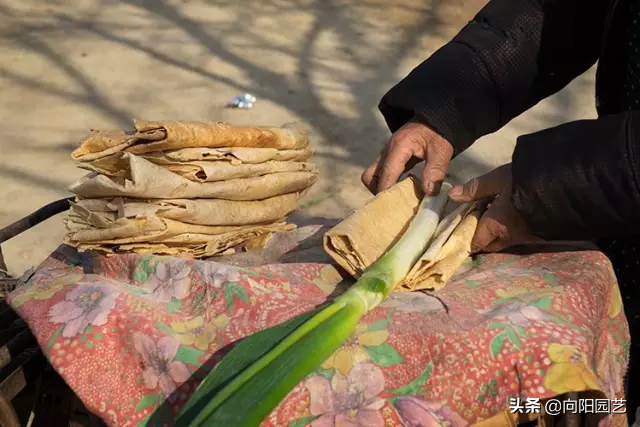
[362,0,640,423]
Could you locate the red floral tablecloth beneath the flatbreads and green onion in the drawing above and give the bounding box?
[10,223,629,427]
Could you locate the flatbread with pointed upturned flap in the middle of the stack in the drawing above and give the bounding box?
[69,153,318,200]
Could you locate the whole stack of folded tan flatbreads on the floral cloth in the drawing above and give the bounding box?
[65,121,318,258]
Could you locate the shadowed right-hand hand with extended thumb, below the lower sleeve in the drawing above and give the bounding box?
[449,163,541,252]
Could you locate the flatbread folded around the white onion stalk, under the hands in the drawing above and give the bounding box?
[324,177,484,291]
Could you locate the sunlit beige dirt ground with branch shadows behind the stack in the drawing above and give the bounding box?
[0,0,594,273]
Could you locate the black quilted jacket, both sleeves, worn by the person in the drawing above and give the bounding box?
[379,0,640,240]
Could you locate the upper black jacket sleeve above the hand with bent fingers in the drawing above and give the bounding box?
[379,0,607,154]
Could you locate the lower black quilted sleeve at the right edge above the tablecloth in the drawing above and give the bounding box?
[512,110,640,240]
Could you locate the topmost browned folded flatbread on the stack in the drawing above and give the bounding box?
[71,120,308,161]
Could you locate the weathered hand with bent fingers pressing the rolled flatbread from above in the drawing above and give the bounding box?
[362,120,453,196]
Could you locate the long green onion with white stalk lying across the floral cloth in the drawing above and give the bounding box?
[176,183,451,427]
